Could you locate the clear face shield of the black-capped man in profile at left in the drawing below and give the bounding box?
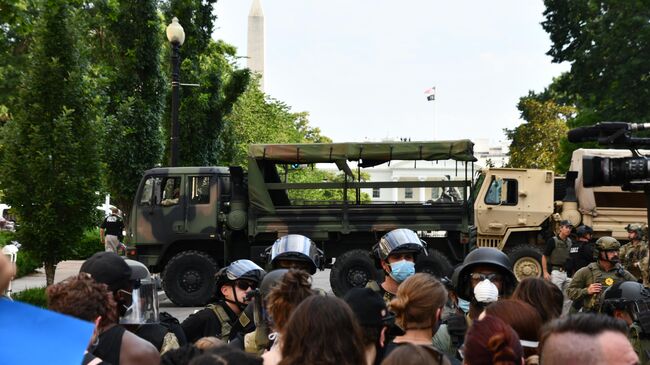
[120,259,159,324]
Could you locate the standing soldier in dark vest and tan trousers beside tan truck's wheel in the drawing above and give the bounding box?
[542,220,573,291]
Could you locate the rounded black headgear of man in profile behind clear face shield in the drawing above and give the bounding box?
[79,252,131,291]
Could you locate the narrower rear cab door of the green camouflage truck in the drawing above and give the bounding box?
[187,174,219,239]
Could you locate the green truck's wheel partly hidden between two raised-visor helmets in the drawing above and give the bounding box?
[330,250,377,297]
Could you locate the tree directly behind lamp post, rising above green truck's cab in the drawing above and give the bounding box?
[163,0,250,166]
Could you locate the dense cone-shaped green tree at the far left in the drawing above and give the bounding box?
[0,0,99,284]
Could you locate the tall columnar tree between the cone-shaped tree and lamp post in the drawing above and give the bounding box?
[102,0,165,211]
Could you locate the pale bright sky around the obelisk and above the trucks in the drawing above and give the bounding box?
[213,0,569,145]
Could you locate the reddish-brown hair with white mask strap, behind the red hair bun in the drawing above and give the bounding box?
[485,299,542,364]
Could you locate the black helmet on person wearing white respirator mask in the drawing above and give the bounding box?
[456,247,517,300]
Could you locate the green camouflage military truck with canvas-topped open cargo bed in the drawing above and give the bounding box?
[128,140,475,306]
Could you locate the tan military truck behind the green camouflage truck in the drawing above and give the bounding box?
[472,149,647,279]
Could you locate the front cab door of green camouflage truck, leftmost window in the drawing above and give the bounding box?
[134,175,187,244]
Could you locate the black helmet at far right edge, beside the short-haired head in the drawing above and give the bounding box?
[601,281,650,316]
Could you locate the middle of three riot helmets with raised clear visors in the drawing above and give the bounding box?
[268,234,323,275]
